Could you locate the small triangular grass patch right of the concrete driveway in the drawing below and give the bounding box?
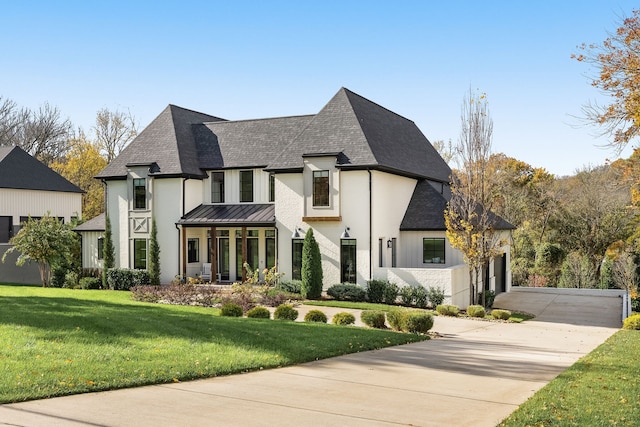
[500,330,640,427]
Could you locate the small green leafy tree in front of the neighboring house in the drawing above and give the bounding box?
[2,213,80,287]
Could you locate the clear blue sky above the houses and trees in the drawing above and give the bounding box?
[0,0,638,175]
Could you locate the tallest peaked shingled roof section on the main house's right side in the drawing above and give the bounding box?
[267,88,451,182]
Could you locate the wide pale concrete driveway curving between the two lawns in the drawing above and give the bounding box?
[0,295,620,427]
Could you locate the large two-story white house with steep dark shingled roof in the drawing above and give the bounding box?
[83,88,510,307]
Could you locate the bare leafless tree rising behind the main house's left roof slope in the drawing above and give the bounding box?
[93,108,138,162]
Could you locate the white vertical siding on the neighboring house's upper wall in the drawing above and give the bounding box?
[0,188,82,225]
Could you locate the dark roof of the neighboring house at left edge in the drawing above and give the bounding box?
[0,147,83,193]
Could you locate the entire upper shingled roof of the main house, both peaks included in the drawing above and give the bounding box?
[96,88,451,182]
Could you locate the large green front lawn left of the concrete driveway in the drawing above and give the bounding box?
[0,285,427,403]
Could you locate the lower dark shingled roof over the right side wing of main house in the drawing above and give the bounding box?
[400,180,515,231]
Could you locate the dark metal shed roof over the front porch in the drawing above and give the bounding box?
[178,204,276,227]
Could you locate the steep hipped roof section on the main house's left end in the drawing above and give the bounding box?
[96,105,224,179]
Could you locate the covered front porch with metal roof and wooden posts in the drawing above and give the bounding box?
[177,204,277,283]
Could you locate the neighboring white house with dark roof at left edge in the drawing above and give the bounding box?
[0,146,82,283]
